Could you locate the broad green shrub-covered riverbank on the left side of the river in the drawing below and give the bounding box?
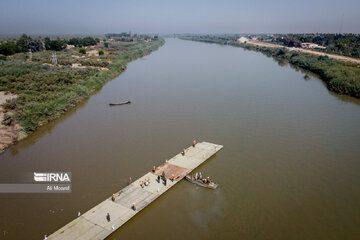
[0,38,164,152]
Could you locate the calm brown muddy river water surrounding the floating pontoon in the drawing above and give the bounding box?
[0,39,360,240]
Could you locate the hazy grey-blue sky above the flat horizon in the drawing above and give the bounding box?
[0,0,360,34]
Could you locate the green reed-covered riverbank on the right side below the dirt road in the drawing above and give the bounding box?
[181,35,360,98]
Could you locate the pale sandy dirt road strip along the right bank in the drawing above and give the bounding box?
[247,40,360,64]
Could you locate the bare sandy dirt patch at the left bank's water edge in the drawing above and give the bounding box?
[0,92,26,152]
